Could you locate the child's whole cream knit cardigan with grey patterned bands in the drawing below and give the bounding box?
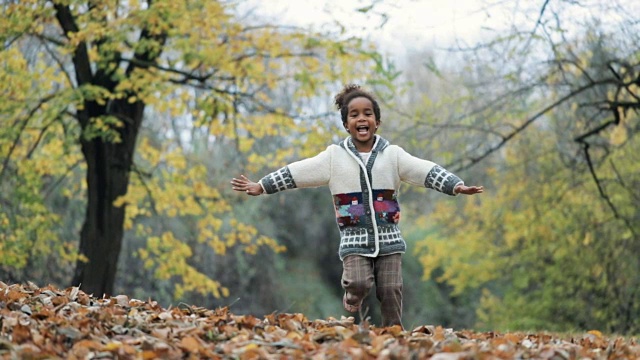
[260,135,463,260]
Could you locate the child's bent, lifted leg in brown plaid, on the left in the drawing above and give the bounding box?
[342,255,373,312]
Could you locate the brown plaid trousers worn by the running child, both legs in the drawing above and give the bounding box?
[342,254,402,327]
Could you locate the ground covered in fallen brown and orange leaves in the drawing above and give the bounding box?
[0,282,640,360]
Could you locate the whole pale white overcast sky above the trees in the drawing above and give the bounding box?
[245,0,640,62]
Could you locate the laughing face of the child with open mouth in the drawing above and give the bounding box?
[344,97,380,152]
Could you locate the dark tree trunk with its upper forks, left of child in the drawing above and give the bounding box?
[53,2,167,296]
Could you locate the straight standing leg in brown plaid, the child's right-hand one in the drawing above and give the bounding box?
[374,254,402,327]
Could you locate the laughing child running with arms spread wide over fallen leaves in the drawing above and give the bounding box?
[231,85,483,326]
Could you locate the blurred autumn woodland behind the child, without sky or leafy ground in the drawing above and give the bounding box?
[0,0,640,334]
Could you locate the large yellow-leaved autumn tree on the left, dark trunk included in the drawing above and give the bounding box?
[0,1,375,298]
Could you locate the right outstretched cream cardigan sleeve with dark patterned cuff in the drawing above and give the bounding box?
[398,148,464,196]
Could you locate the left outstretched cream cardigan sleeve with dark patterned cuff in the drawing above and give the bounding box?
[260,148,331,194]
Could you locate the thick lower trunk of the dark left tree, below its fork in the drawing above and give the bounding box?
[73,101,144,297]
